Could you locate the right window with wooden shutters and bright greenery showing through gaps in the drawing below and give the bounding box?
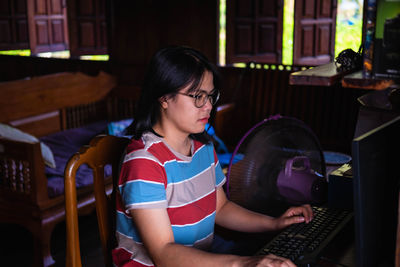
[220,0,363,66]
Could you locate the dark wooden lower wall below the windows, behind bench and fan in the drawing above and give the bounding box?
[0,56,366,153]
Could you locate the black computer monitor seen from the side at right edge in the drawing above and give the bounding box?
[352,116,400,266]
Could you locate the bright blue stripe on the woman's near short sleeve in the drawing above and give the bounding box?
[119,180,167,206]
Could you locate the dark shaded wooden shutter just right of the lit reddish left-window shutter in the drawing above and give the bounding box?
[68,0,108,57]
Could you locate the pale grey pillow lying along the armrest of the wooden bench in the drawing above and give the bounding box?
[0,123,56,168]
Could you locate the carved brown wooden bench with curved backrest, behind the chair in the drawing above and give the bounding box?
[0,72,134,266]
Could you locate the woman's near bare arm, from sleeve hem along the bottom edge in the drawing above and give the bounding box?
[130,209,294,267]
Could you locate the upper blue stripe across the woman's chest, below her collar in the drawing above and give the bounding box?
[164,145,214,184]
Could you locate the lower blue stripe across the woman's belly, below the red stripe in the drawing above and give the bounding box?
[172,212,215,245]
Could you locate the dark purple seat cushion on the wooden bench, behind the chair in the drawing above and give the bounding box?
[40,121,111,197]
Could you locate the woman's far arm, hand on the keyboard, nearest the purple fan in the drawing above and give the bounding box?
[216,187,313,232]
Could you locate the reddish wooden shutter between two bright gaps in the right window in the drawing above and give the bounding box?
[293,0,337,66]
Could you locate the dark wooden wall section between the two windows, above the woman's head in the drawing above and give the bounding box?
[108,0,218,87]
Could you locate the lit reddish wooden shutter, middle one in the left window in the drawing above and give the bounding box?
[26,0,68,54]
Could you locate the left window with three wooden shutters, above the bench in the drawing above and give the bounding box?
[0,0,108,59]
